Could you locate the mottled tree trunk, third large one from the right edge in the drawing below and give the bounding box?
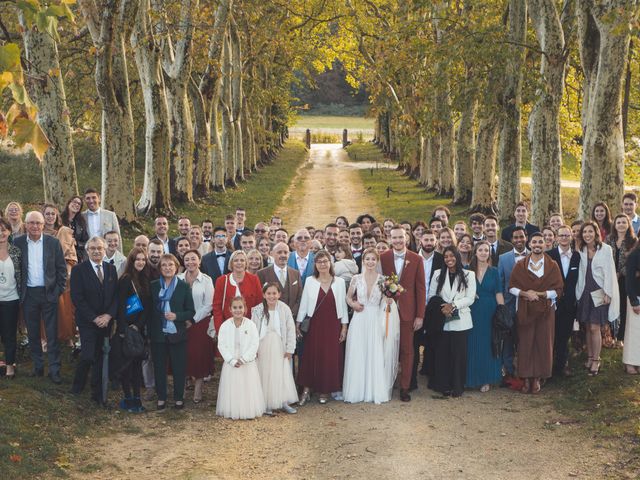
[498,0,527,220]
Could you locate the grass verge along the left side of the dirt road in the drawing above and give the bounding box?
[0,141,308,479]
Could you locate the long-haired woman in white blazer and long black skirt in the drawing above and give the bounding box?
[429,246,476,397]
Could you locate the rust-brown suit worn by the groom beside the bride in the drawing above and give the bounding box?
[380,249,426,390]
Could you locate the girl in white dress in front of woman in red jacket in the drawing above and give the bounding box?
[216,297,265,420]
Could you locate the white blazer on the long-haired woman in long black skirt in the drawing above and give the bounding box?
[429,268,476,332]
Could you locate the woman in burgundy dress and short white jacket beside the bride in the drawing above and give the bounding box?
[297,250,349,406]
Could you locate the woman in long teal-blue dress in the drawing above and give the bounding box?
[466,240,504,393]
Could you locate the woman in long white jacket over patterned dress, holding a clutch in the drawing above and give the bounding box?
[576,221,620,376]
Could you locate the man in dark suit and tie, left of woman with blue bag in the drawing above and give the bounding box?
[71,237,118,403]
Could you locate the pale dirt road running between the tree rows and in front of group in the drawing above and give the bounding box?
[68,145,616,480]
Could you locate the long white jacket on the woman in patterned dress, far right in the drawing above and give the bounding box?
[576,243,620,322]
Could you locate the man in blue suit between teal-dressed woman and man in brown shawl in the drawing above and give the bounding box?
[498,226,529,377]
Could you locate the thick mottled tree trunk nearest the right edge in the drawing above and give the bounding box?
[577,0,638,218]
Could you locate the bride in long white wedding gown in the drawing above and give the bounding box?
[343,248,400,403]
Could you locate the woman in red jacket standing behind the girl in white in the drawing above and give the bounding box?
[213,250,262,332]
